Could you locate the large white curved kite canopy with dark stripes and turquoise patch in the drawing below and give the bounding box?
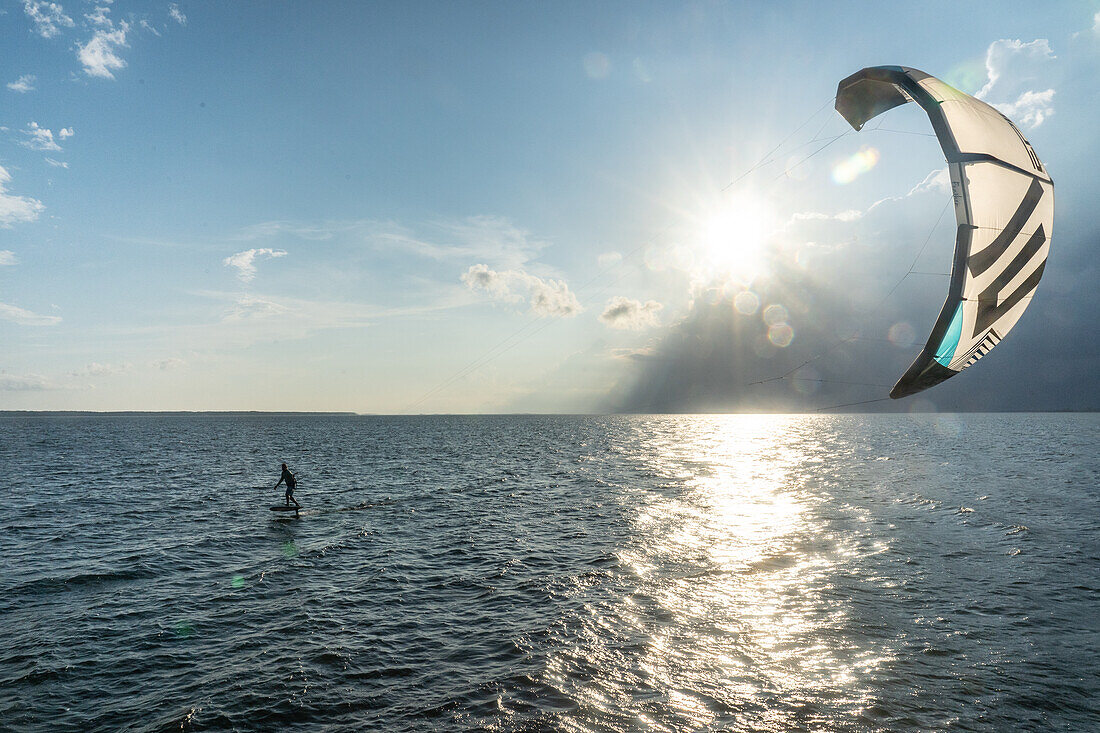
[836,66,1054,400]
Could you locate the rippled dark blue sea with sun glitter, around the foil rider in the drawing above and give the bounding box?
[0,414,1100,732]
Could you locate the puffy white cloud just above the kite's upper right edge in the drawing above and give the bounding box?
[975,39,1056,129]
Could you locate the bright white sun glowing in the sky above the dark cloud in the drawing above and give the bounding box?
[694,194,776,285]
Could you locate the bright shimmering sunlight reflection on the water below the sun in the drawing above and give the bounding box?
[539,415,890,731]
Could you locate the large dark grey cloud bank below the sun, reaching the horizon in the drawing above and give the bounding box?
[605,197,1100,413]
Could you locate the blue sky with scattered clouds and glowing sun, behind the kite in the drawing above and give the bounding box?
[0,0,1100,413]
